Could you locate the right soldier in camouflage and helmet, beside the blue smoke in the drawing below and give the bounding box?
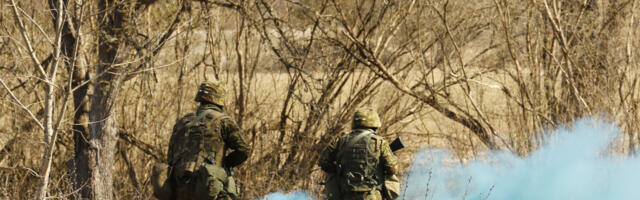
[318,109,399,200]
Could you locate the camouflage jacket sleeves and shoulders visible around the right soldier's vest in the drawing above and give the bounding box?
[318,130,398,176]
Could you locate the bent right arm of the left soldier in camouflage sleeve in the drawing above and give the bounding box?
[222,119,251,167]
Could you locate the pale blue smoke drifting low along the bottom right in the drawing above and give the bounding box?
[263,119,640,200]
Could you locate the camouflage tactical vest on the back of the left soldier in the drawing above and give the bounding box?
[170,109,229,177]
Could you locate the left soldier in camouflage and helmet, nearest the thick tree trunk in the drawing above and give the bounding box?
[167,81,250,200]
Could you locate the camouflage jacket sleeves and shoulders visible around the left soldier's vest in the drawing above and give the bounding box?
[167,104,250,170]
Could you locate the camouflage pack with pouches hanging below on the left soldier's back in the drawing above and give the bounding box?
[159,110,237,199]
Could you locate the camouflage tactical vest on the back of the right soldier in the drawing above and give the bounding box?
[336,130,384,192]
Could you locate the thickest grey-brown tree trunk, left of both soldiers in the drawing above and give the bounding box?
[74,0,124,200]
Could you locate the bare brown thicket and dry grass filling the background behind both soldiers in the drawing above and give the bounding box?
[0,0,640,199]
